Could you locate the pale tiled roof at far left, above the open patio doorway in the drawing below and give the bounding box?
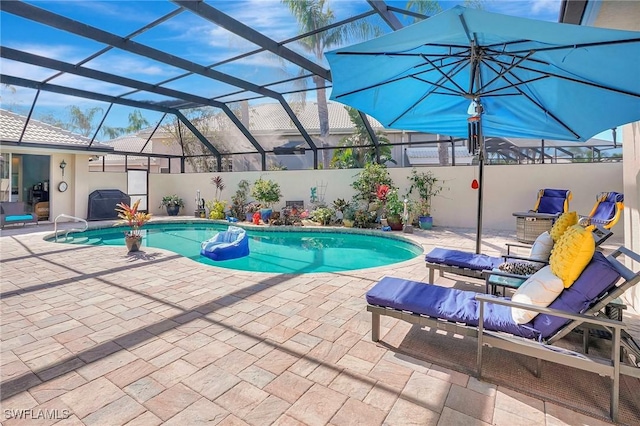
[0,109,113,151]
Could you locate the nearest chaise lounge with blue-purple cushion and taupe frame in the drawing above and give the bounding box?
[366,247,640,421]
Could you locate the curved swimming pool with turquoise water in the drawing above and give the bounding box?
[52,222,422,274]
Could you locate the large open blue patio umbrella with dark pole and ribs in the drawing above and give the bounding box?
[326,6,640,252]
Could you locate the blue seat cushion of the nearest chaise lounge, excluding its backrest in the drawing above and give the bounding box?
[366,277,539,338]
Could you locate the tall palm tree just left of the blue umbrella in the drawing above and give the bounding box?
[282,0,381,168]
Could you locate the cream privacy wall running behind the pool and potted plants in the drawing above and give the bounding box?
[142,163,623,234]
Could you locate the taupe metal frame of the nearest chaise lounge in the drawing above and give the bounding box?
[367,247,640,421]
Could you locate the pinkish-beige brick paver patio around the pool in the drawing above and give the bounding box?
[0,221,640,425]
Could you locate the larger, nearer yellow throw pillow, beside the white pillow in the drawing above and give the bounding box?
[549,225,596,288]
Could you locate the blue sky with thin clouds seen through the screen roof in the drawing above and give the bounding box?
[6,0,616,141]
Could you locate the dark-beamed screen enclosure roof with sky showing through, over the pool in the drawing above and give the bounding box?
[0,0,560,170]
